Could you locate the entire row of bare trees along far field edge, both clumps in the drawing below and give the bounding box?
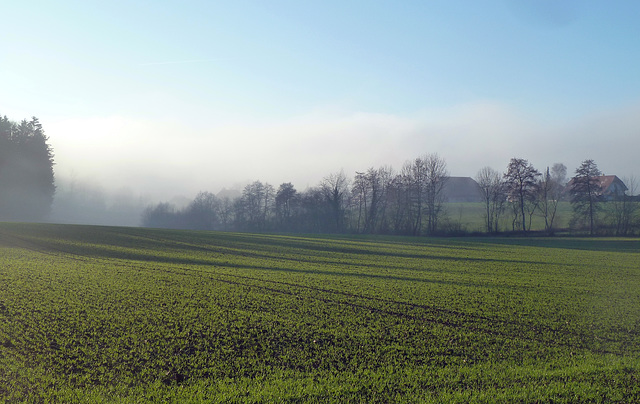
[142,154,640,236]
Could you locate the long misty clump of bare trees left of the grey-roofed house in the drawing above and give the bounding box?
[142,154,448,235]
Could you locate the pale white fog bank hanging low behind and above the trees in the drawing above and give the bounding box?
[49,103,640,205]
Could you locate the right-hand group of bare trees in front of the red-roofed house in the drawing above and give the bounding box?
[476,158,640,236]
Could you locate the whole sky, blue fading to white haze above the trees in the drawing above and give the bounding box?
[0,0,640,199]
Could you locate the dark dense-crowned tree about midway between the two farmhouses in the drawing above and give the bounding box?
[504,158,540,231]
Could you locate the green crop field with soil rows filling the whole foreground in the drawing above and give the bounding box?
[0,223,640,403]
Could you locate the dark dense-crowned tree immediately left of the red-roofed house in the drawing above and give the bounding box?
[569,159,602,235]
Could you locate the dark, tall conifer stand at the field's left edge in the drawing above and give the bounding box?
[0,116,55,221]
